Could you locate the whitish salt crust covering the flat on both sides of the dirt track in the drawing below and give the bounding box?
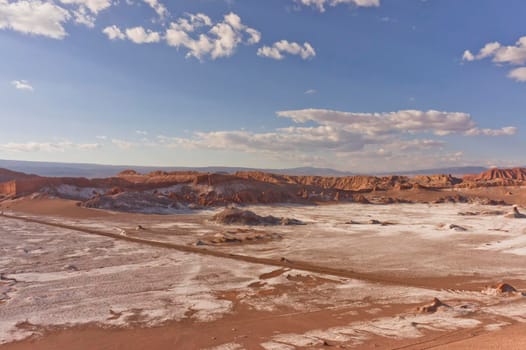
[0,202,526,350]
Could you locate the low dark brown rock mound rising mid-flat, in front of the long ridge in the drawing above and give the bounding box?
[212,208,303,226]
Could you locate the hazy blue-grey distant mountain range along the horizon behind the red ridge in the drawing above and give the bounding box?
[0,160,496,178]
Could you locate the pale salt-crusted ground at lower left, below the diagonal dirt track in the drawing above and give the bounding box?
[0,219,272,344]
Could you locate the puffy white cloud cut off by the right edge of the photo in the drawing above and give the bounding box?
[462,36,526,82]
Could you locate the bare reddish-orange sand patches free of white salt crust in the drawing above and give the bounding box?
[0,197,526,350]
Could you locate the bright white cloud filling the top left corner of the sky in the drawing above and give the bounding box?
[0,0,71,39]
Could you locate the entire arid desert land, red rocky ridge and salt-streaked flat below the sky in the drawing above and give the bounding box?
[0,169,526,350]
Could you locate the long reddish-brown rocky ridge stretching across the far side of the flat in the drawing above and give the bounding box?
[0,169,526,211]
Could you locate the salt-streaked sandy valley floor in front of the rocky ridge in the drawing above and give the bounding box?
[0,200,526,349]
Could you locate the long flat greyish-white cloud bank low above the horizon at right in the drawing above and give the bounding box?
[157,109,517,170]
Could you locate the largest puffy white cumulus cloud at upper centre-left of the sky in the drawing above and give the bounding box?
[166,12,261,60]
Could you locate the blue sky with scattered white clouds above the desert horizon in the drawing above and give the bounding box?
[0,0,526,172]
